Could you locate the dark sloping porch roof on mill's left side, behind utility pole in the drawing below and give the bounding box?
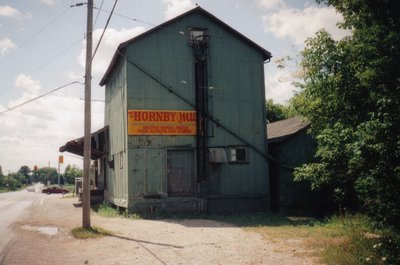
[59,126,108,160]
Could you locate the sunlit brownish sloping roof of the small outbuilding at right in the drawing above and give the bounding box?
[267,116,311,143]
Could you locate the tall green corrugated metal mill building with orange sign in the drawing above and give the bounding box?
[86,7,271,212]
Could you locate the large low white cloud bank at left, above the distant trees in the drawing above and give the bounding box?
[0,74,104,171]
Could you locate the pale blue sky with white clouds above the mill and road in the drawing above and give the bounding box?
[0,0,347,174]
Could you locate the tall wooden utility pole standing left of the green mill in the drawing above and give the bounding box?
[82,0,93,228]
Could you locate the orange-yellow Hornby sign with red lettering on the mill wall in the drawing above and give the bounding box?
[128,110,196,135]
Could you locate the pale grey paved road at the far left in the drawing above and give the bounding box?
[0,186,46,264]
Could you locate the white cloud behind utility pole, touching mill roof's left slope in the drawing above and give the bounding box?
[78,27,145,76]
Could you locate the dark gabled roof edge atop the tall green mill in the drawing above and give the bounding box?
[100,6,272,86]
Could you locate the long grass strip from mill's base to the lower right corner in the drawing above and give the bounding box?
[88,203,400,265]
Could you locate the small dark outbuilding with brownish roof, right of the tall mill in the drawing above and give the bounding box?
[267,116,329,214]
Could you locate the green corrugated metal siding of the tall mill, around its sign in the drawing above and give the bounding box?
[106,9,269,208]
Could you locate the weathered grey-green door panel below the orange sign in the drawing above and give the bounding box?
[167,150,195,196]
